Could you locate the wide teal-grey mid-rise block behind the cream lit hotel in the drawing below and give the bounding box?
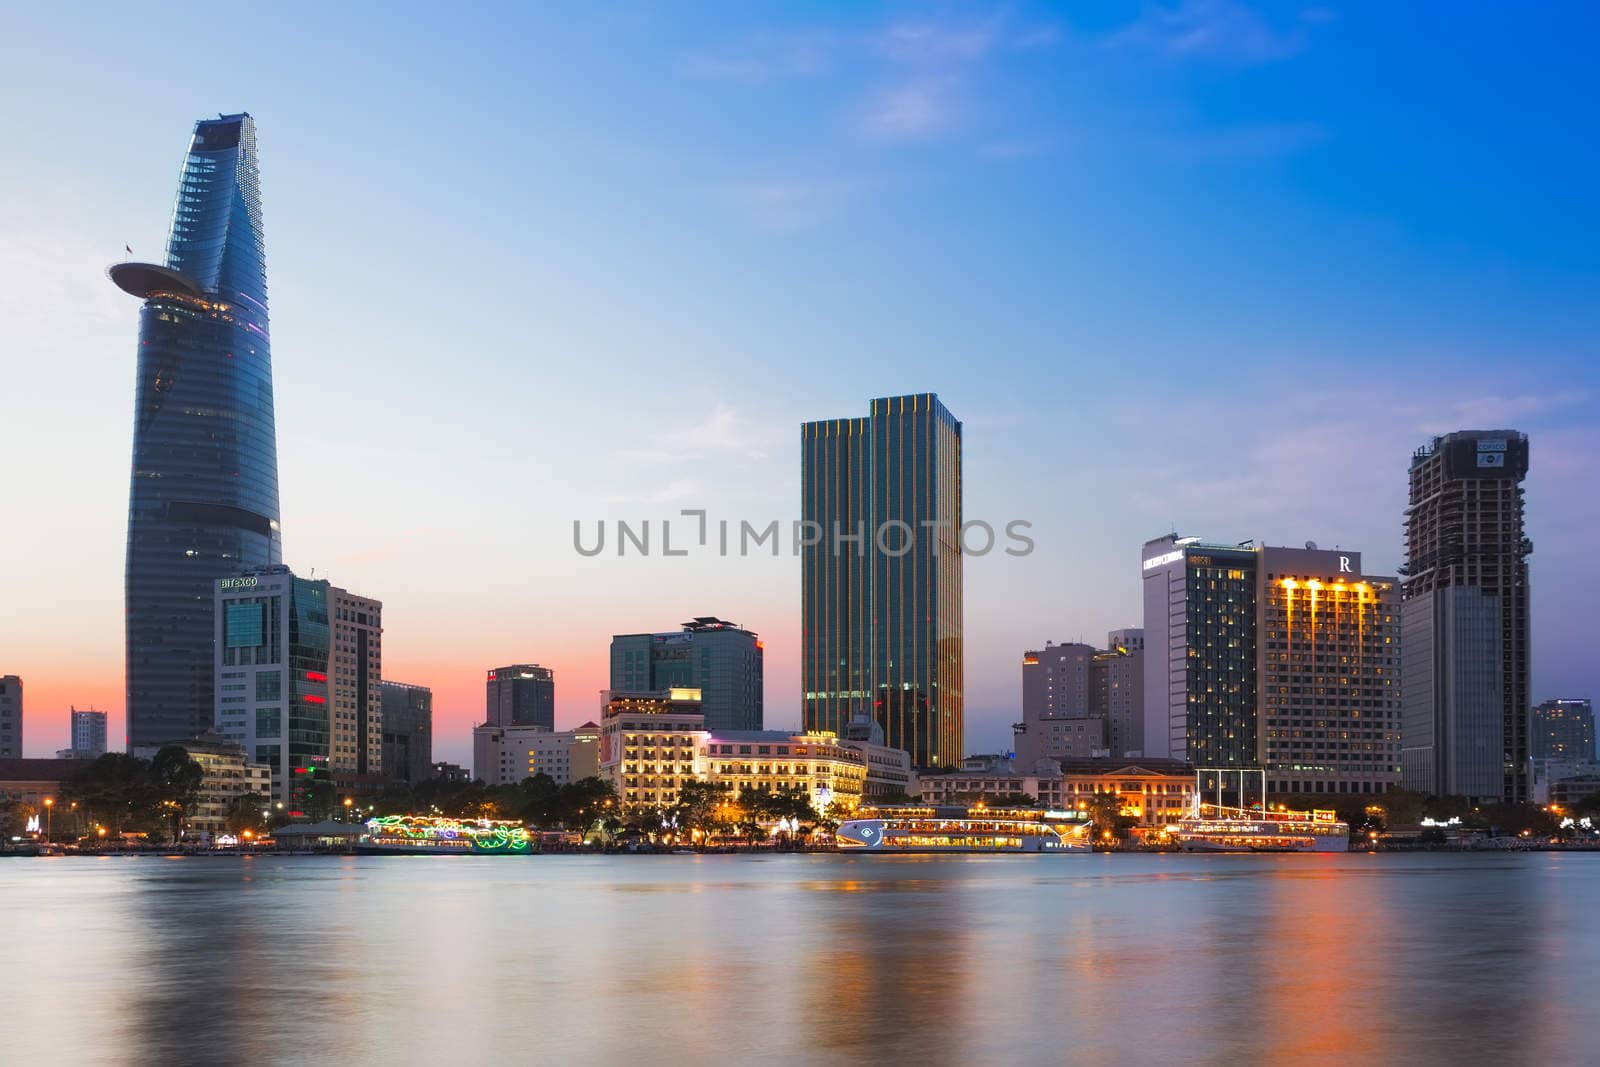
[611,616,765,729]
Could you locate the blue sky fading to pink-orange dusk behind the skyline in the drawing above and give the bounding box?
[0,0,1600,763]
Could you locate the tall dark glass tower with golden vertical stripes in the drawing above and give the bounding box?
[800,394,963,768]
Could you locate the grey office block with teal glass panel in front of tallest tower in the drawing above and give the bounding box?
[214,566,331,803]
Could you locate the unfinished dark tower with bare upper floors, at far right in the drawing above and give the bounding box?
[1402,430,1533,801]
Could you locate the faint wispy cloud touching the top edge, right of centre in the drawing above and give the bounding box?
[1106,0,1326,64]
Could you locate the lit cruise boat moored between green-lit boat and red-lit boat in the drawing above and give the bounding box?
[834,805,1091,853]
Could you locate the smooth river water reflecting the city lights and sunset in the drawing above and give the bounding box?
[0,853,1600,1065]
